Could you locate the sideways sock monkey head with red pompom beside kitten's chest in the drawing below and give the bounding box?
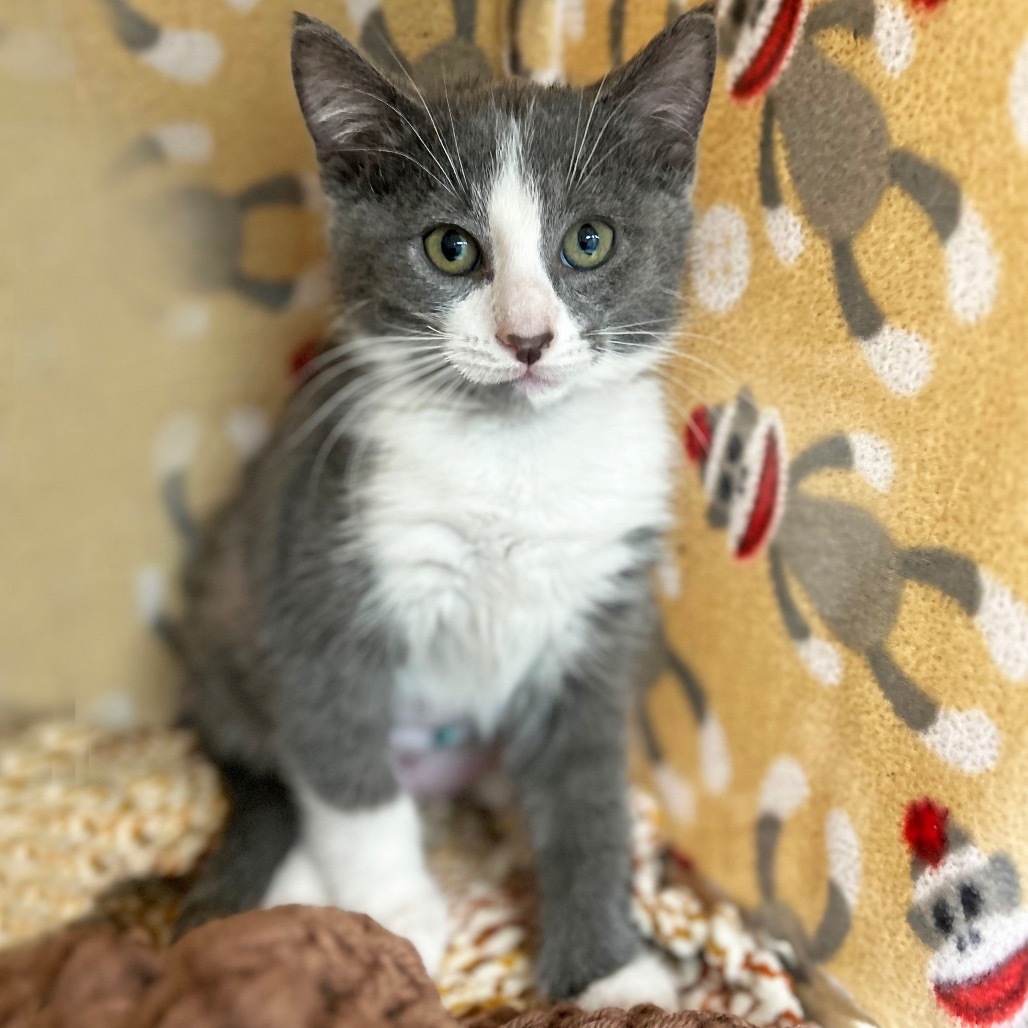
[686,390,787,560]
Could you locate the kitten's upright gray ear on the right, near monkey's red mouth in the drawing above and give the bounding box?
[599,5,718,174]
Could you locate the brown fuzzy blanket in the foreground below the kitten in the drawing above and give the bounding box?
[0,907,744,1028]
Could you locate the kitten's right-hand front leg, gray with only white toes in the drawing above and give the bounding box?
[505,596,676,1006]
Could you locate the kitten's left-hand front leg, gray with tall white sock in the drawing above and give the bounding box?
[264,458,448,974]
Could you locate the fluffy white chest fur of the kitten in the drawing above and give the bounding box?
[365,379,675,729]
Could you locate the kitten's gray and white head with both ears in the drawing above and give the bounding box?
[293,10,715,406]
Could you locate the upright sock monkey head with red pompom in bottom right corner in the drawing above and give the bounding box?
[903,799,1028,1028]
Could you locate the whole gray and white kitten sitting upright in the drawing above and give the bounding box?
[174,10,715,1005]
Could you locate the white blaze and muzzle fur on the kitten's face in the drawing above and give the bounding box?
[443,129,590,402]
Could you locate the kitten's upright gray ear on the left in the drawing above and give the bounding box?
[292,12,409,156]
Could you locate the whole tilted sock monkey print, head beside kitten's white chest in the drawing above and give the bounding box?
[686,389,1028,774]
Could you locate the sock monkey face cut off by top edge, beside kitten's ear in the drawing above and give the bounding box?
[718,0,806,100]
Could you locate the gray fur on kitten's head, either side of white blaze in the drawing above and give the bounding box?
[294,14,713,388]
